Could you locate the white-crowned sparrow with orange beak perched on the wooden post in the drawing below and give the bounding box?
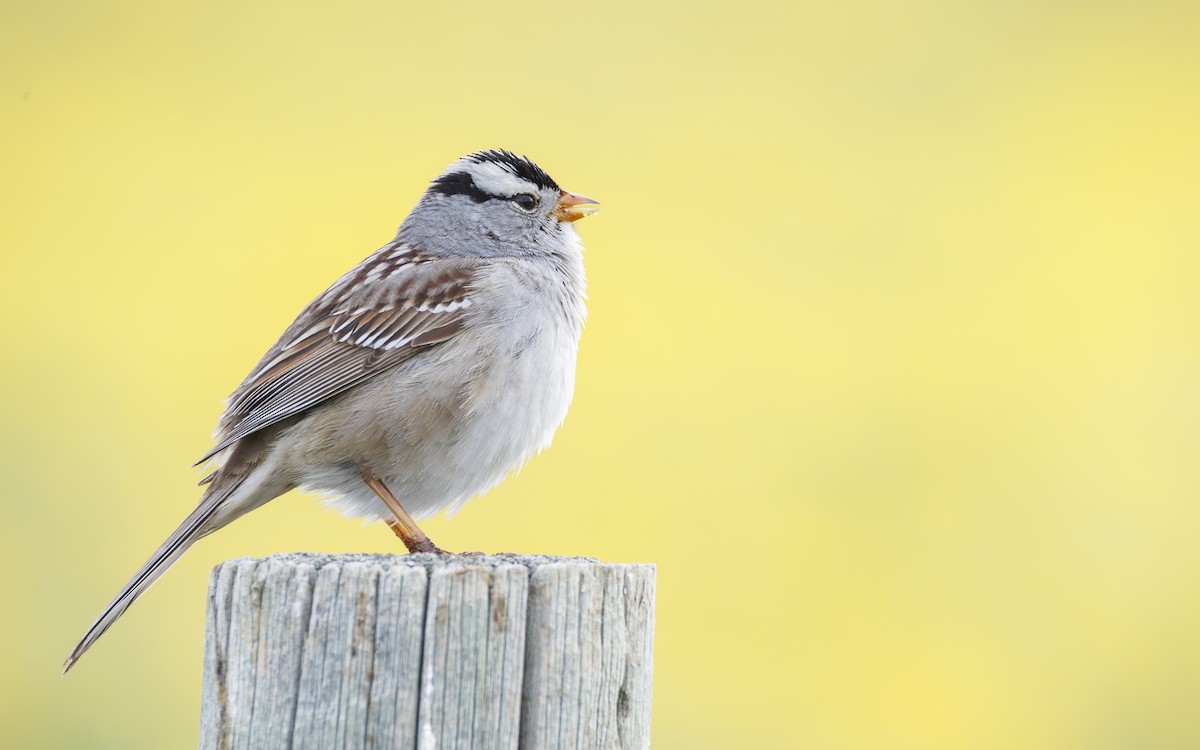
[62,150,599,674]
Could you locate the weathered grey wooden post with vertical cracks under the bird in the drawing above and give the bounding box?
[200,554,654,750]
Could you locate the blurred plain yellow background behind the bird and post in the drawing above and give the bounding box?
[0,0,1200,750]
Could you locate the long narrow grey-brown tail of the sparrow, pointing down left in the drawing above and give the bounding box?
[62,474,246,674]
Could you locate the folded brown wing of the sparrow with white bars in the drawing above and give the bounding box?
[198,247,474,463]
